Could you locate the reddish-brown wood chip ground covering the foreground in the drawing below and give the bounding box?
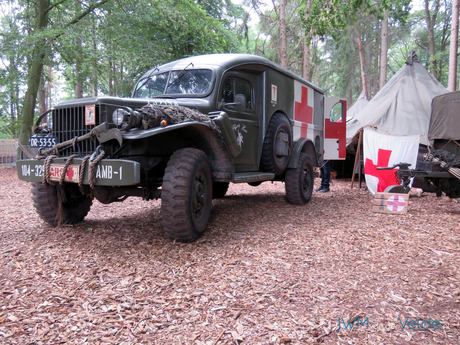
[0,168,460,345]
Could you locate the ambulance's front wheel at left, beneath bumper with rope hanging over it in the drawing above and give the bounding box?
[32,182,93,226]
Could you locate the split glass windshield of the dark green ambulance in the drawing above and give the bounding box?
[134,69,212,98]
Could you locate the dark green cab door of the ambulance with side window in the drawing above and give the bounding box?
[219,72,261,172]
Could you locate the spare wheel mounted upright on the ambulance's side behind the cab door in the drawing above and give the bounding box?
[260,113,292,175]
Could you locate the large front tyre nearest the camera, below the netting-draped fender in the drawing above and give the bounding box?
[161,148,212,242]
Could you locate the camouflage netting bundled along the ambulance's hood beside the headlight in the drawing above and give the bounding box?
[139,104,221,135]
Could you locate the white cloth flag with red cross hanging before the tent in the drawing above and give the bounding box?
[363,128,420,194]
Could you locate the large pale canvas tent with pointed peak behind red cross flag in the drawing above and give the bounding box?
[347,52,447,146]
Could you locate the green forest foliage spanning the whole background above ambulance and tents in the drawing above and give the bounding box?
[0,0,451,135]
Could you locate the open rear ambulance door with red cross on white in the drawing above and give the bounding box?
[323,97,347,160]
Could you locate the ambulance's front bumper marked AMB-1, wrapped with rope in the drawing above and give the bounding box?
[16,158,141,186]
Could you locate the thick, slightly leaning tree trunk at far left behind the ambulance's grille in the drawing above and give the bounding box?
[19,0,50,145]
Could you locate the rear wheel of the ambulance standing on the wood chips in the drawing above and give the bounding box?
[284,152,313,205]
